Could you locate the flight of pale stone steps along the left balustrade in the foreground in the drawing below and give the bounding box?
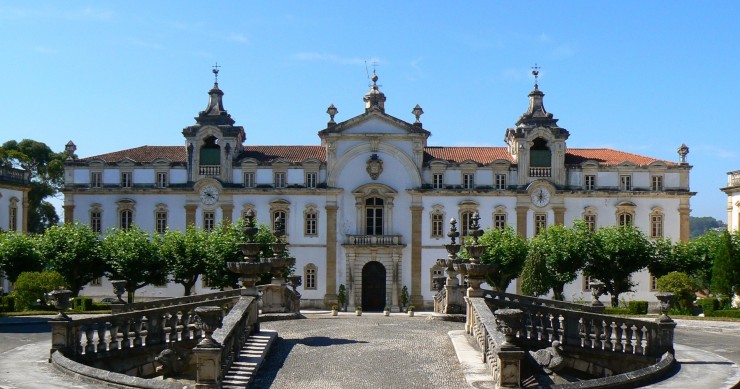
[223,331,277,389]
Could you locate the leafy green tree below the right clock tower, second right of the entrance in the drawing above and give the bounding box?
[522,221,594,301]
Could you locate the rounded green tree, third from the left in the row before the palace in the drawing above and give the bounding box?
[102,227,167,303]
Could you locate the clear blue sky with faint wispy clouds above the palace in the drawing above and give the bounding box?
[0,1,740,222]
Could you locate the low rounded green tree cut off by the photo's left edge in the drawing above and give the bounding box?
[0,231,44,282]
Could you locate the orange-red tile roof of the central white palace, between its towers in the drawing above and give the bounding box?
[80,146,675,166]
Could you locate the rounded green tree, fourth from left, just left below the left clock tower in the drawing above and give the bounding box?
[155,226,208,296]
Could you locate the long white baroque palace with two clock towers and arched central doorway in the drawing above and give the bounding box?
[63,71,694,310]
